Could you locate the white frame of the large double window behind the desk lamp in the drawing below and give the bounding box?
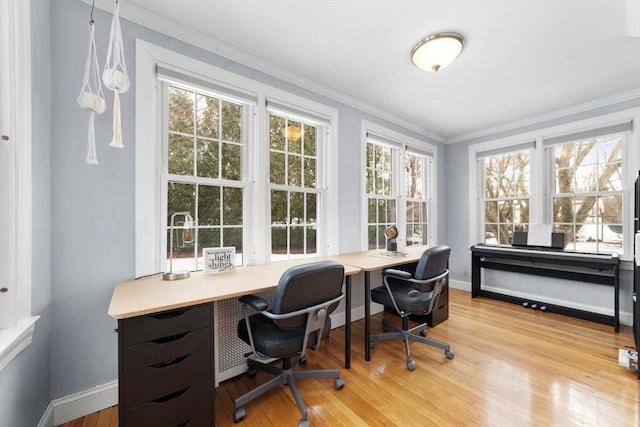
[135,39,339,277]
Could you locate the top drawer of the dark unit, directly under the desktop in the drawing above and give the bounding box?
[118,304,212,346]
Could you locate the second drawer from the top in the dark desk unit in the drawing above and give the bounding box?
[122,328,213,373]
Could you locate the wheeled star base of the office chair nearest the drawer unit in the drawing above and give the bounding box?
[233,356,344,427]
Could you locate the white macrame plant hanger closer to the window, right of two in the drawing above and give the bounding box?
[102,0,130,148]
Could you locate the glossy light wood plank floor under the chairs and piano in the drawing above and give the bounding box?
[57,289,640,427]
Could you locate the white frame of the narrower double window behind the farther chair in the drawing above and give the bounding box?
[360,120,438,251]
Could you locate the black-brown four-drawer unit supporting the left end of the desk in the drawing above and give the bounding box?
[118,304,215,427]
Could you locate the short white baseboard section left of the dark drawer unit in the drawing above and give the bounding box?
[50,381,118,427]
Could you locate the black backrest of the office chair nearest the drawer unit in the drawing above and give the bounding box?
[271,261,344,329]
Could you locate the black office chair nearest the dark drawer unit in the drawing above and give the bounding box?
[233,261,344,426]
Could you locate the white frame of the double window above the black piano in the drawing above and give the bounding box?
[468,108,640,261]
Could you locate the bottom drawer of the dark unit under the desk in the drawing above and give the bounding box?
[124,382,213,427]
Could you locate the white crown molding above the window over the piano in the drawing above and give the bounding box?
[446,89,640,144]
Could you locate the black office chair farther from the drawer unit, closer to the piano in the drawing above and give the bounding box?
[369,246,454,371]
